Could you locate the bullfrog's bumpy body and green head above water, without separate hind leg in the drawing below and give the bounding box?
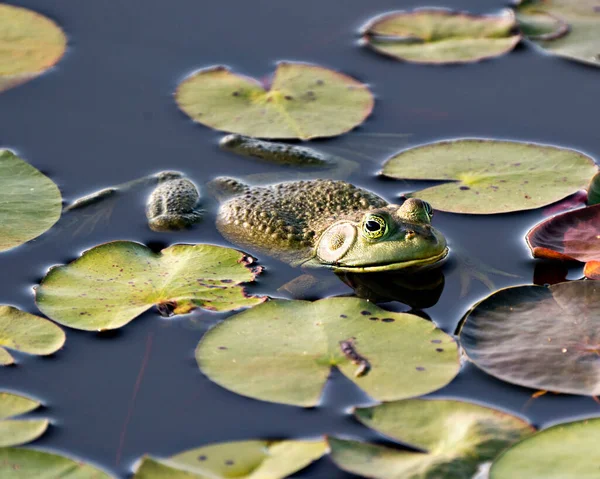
[210,178,448,272]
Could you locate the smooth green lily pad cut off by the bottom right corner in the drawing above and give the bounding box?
[490,418,600,479]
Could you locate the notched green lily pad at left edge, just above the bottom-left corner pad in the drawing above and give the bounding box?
[0,392,48,448]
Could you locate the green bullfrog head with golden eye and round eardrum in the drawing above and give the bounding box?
[306,198,448,273]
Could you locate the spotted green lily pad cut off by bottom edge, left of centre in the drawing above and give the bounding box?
[134,440,328,479]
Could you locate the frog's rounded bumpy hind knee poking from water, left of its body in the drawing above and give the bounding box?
[146,176,202,231]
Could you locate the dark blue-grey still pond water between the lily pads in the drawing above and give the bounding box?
[0,0,600,479]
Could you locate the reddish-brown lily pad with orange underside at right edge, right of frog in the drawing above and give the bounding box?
[527,205,600,279]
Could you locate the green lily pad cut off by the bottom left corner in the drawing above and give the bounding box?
[0,447,113,479]
